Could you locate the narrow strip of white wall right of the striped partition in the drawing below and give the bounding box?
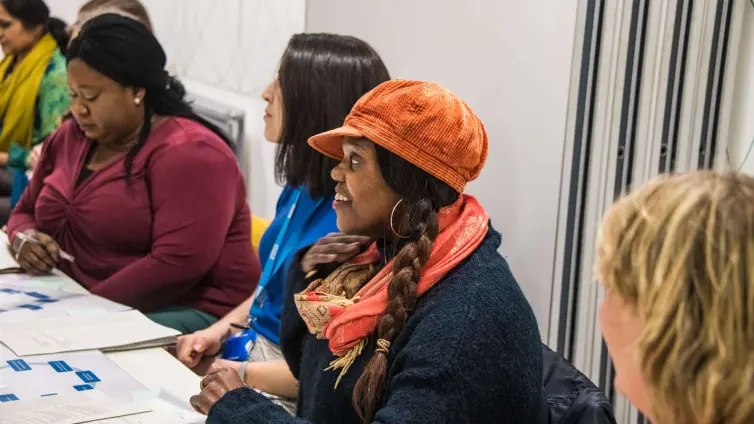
[728,2,754,175]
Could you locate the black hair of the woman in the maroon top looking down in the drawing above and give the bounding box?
[68,13,233,181]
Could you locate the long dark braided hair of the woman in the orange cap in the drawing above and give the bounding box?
[353,146,460,423]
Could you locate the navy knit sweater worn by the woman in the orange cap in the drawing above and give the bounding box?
[207,229,547,424]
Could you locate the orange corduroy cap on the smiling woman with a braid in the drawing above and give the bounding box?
[309,80,489,193]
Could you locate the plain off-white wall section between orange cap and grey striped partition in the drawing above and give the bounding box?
[306,0,577,337]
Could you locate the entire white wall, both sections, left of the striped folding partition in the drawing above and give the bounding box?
[50,0,577,335]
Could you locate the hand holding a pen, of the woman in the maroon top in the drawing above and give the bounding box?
[13,230,60,275]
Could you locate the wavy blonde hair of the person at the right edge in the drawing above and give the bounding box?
[596,171,754,424]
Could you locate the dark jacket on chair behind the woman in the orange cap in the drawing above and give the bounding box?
[542,346,615,424]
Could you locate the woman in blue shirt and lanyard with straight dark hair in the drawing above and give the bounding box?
[176,34,390,411]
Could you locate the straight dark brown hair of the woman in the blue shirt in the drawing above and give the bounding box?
[275,34,390,197]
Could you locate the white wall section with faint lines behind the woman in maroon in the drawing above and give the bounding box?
[48,0,305,217]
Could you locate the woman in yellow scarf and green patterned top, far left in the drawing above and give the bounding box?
[0,0,70,222]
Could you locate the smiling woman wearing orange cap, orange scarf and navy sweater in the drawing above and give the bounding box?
[191,80,546,424]
